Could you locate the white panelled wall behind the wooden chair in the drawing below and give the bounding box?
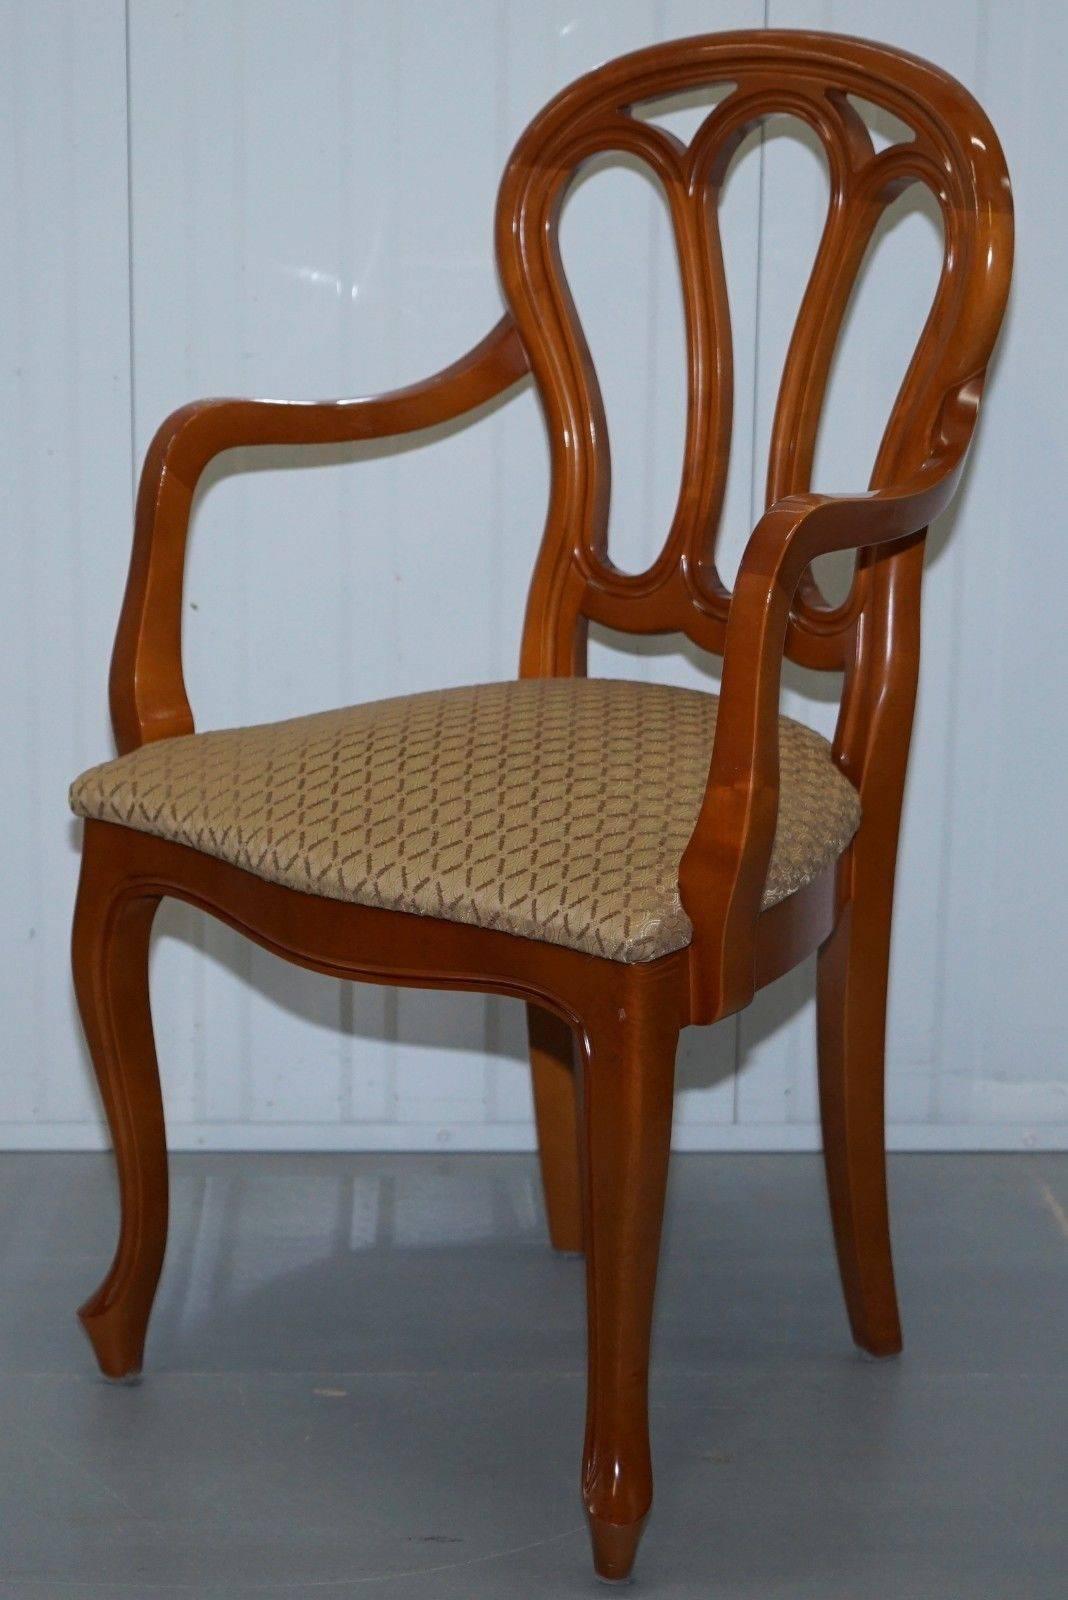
[0,0,1068,1149]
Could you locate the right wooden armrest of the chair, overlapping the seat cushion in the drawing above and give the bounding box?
[679,450,964,1013]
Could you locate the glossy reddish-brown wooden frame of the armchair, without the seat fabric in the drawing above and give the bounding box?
[74,32,1012,1578]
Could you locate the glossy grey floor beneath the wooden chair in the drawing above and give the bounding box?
[0,1155,1068,1600]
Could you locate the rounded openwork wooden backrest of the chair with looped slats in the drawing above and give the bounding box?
[497,30,1012,675]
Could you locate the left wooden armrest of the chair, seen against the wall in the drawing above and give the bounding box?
[109,315,529,754]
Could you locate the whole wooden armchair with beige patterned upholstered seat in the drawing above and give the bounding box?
[72,32,1012,1578]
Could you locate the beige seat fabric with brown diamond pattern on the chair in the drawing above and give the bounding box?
[70,678,860,962]
